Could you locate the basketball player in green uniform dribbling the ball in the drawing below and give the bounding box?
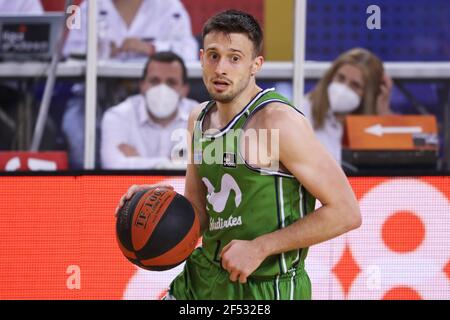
[119,10,361,299]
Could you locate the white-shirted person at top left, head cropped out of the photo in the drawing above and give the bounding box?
[64,0,198,61]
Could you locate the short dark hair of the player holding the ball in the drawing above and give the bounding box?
[202,10,263,56]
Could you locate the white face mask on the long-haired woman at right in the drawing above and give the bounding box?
[328,82,361,113]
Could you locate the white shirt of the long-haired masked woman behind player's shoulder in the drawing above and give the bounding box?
[300,97,344,164]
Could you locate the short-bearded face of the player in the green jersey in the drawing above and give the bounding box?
[200,32,263,103]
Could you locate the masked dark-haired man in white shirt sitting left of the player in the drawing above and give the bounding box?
[100,52,197,169]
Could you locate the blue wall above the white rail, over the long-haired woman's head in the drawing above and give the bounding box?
[306,0,450,61]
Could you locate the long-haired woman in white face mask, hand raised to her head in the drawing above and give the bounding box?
[301,48,392,163]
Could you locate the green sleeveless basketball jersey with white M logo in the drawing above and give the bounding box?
[193,89,315,277]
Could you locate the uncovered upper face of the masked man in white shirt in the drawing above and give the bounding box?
[141,61,188,97]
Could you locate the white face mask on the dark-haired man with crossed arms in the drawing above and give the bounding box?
[145,83,180,119]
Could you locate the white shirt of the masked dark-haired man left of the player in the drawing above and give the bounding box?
[100,94,198,169]
